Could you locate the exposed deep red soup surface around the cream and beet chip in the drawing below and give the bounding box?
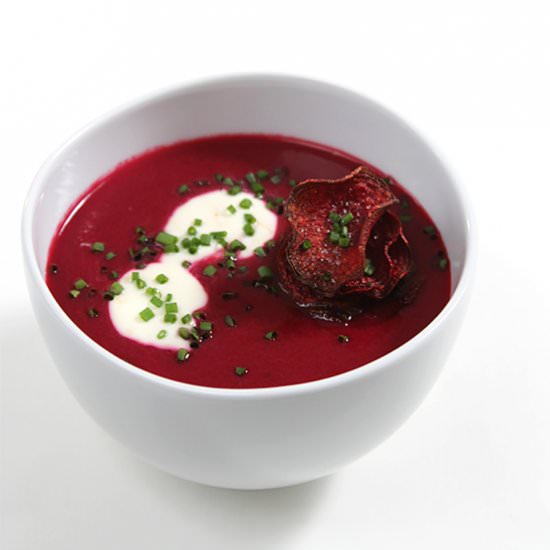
[46,135,450,388]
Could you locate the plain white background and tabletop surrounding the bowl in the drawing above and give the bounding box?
[0,0,550,550]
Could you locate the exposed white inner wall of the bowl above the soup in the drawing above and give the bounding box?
[25,77,468,298]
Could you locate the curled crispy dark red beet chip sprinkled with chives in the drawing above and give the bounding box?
[278,166,412,306]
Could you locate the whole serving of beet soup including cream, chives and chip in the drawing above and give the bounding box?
[46,135,450,388]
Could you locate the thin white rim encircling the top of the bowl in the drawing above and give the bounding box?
[21,73,477,399]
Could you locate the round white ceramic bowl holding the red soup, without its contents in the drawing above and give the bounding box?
[23,76,475,489]
